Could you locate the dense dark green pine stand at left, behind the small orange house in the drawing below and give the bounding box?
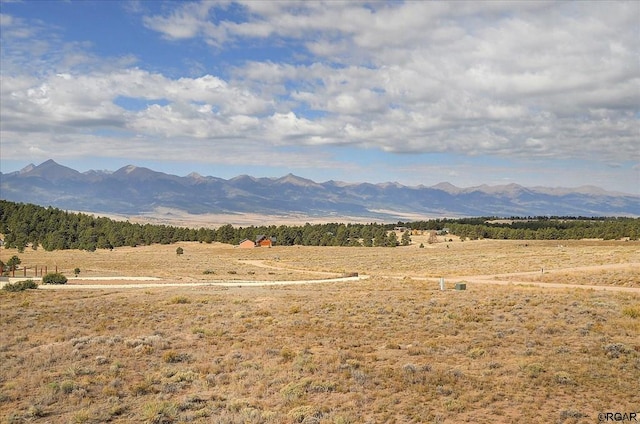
[0,200,408,251]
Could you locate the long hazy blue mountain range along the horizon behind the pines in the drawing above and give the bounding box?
[0,160,640,222]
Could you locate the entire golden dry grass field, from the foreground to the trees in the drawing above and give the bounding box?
[0,237,640,424]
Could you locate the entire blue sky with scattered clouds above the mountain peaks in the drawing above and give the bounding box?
[0,0,640,195]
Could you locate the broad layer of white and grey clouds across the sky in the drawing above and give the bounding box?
[0,1,640,174]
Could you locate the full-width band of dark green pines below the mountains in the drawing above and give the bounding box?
[0,200,640,251]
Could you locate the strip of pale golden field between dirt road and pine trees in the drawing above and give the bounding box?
[5,236,640,287]
